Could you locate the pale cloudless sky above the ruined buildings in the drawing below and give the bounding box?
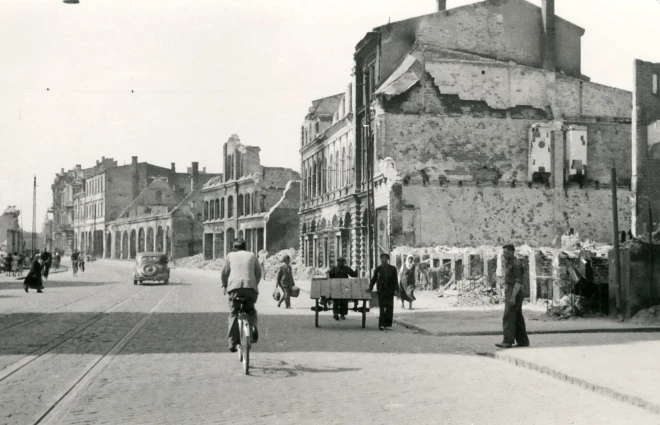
[0,0,660,230]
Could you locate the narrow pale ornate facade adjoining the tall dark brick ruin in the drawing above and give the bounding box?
[300,84,356,267]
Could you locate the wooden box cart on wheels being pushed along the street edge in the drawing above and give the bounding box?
[310,277,372,328]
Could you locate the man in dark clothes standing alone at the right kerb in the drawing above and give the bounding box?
[495,244,529,348]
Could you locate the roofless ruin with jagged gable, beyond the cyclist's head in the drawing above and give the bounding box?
[202,135,300,259]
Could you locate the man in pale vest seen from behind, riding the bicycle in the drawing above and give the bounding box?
[222,239,261,353]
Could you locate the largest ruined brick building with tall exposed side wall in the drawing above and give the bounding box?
[301,0,632,273]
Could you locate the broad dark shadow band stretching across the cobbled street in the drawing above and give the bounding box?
[0,312,660,356]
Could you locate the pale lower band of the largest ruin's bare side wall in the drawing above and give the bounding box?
[403,185,630,247]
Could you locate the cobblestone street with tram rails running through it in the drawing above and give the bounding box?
[0,262,660,424]
